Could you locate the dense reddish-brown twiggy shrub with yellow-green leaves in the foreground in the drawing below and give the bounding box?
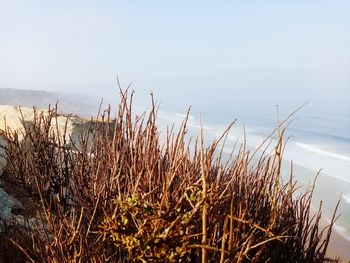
[1,92,336,262]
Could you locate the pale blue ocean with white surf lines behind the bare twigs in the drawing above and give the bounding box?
[158,111,350,245]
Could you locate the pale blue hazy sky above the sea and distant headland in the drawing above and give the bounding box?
[0,0,350,113]
